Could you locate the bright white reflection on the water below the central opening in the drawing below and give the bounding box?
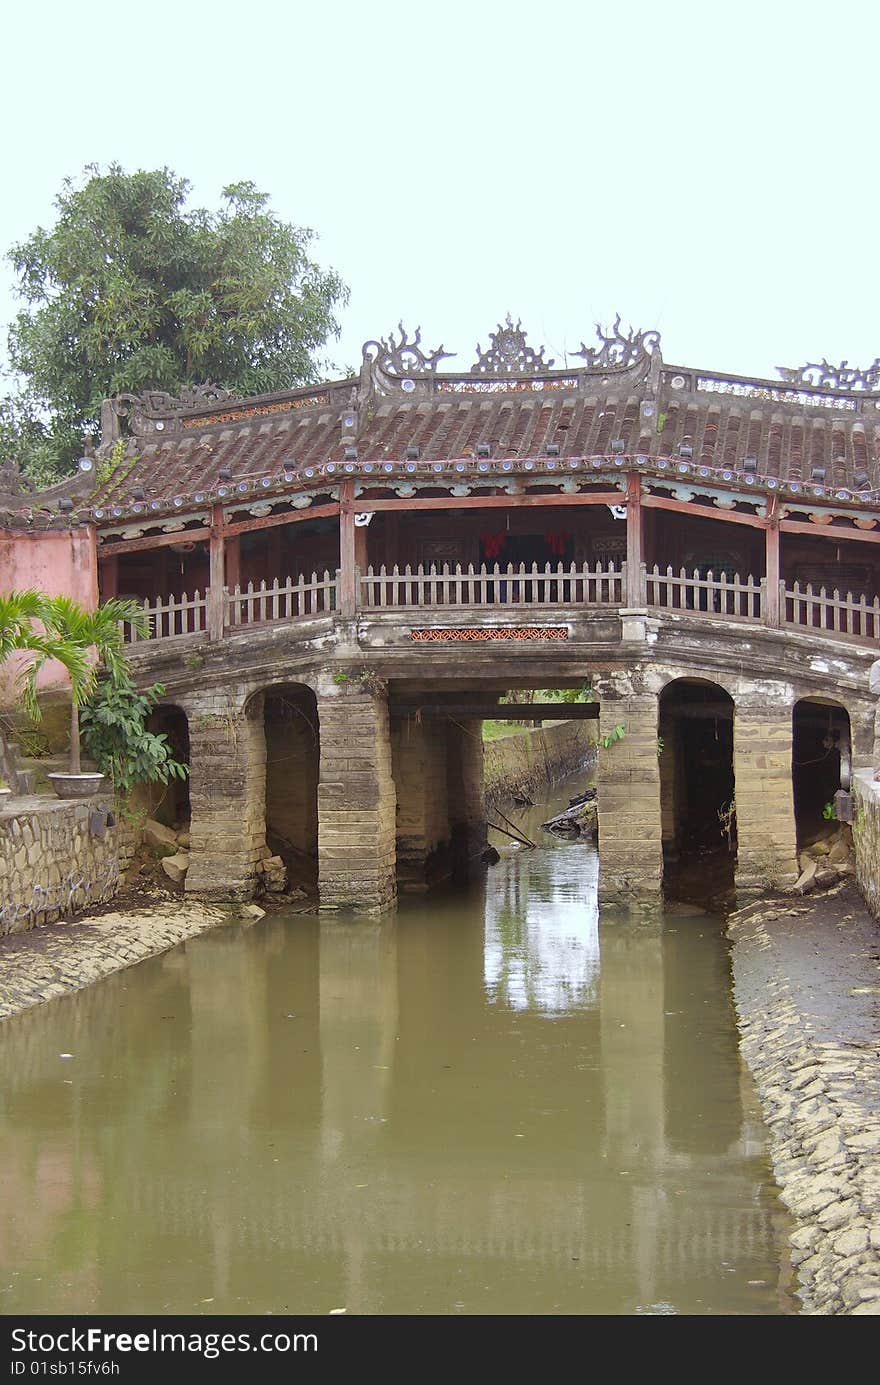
[484,846,599,1014]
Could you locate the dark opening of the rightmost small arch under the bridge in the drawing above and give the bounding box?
[791,697,852,848]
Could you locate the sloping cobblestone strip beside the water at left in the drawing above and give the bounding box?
[0,900,229,1019]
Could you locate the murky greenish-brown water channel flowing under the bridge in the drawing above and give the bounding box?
[0,783,791,1314]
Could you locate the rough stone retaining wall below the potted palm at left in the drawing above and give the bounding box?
[0,798,119,936]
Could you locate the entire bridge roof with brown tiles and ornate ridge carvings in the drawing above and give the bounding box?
[5,320,880,526]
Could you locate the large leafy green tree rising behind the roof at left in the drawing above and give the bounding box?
[7,163,348,482]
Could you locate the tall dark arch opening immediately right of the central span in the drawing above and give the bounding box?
[657,676,736,895]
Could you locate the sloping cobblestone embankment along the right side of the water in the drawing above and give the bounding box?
[729,885,880,1316]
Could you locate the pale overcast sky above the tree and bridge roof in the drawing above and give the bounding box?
[0,0,880,387]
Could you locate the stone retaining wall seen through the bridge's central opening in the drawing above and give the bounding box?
[484,722,596,803]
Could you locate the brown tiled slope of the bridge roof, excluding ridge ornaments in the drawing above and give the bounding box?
[85,368,880,520]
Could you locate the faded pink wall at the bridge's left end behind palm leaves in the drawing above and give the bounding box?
[0,528,98,704]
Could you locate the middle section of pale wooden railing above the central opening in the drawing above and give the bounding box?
[360,562,626,609]
